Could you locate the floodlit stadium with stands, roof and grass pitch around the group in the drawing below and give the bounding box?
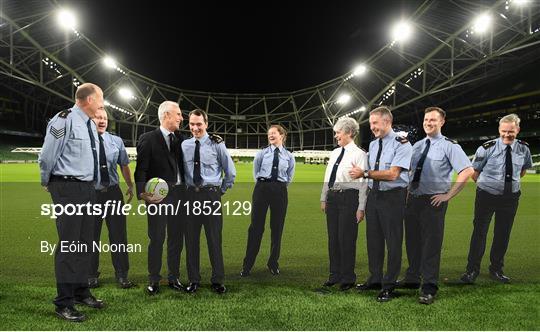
[0,0,540,330]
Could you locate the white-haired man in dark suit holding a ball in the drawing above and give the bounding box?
[135,101,185,295]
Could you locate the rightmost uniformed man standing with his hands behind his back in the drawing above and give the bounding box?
[461,114,532,284]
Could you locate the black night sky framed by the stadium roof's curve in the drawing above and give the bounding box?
[59,0,422,93]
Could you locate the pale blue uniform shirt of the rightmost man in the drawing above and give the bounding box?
[473,138,532,195]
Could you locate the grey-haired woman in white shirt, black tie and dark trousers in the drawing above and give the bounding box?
[321,118,367,291]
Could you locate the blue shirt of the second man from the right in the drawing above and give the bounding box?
[410,133,472,195]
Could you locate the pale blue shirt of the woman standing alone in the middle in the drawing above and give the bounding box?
[253,145,295,183]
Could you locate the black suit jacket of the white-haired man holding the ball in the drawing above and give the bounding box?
[134,128,185,198]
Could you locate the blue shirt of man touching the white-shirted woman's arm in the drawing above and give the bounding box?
[369,129,412,191]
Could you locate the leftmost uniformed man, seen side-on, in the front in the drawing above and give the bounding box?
[39,83,104,321]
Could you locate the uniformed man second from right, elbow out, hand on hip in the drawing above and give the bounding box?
[398,107,474,304]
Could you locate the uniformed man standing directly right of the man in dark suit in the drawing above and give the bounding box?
[182,109,236,294]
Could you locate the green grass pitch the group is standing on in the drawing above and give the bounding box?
[0,163,540,330]
